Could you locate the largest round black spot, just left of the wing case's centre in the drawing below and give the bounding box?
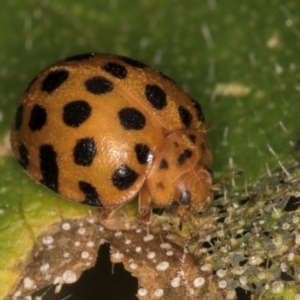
[63,100,92,127]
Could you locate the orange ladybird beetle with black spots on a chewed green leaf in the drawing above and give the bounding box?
[11,53,213,221]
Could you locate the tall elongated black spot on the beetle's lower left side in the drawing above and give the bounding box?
[39,145,59,193]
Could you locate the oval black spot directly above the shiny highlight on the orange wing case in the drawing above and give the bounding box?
[118,107,146,130]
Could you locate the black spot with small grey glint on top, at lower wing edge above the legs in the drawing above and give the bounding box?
[111,164,139,190]
